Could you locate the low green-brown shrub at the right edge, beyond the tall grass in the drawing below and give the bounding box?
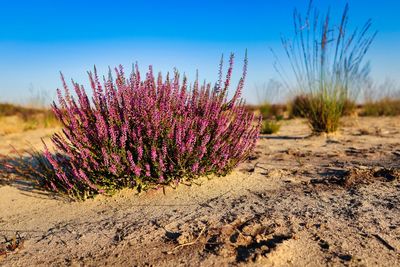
[360,98,400,116]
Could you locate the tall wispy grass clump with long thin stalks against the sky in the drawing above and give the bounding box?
[276,1,376,133]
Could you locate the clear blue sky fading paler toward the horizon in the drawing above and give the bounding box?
[0,0,400,102]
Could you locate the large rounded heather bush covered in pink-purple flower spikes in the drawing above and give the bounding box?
[40,55,260,197]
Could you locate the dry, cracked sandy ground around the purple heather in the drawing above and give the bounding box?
[0,117,400,266]
